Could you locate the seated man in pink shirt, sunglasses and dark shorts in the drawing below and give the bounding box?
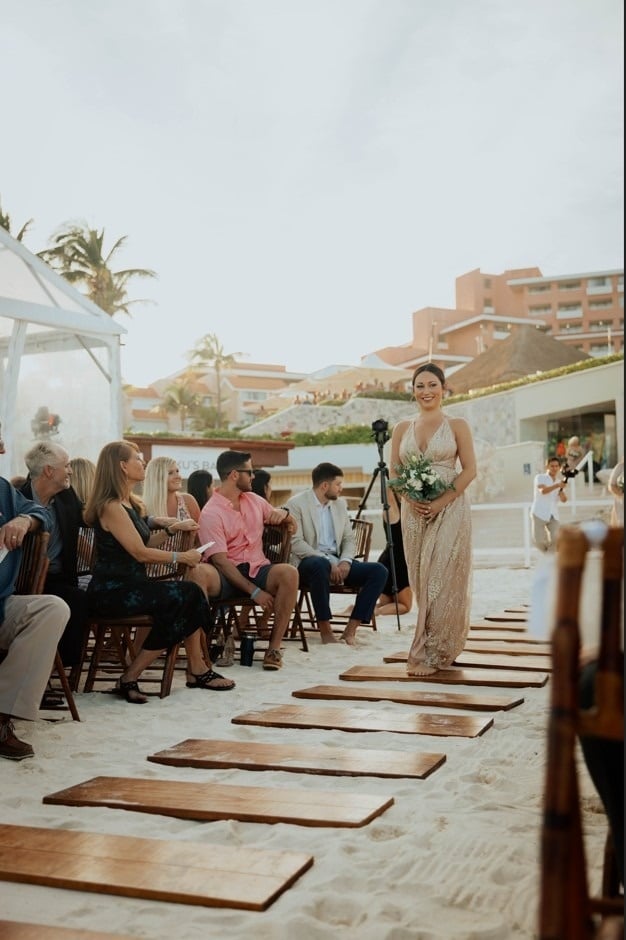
[199,450,298,669]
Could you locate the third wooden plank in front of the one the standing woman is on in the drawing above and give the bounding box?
[148,738,446,779]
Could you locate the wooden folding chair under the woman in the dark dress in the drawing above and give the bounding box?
[83,531,196,698]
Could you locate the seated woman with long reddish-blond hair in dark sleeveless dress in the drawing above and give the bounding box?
[84,441,235,705]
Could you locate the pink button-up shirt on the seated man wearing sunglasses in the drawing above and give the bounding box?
[199,491,272,578]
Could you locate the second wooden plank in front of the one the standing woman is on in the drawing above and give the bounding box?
[231,705,493,738]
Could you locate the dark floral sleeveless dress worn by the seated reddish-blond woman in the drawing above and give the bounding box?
[87,506,212,650]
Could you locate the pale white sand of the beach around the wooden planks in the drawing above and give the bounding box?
[0,568,606,940]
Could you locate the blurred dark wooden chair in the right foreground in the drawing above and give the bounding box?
[539,526,624,940]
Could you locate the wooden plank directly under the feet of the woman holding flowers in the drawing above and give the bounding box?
[339,663,548,689]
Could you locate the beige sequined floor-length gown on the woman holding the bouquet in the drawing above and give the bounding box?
[399,417,472,672]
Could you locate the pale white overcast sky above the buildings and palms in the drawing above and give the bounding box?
[0,0,623,385]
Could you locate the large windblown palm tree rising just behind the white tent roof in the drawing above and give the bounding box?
[39,222,156,317]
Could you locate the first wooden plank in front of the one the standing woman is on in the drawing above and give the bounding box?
[291,685,524,712]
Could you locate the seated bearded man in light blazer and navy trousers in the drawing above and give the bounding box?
[286,463,387,645]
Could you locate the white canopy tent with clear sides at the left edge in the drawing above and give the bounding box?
[0,228,126,476]
